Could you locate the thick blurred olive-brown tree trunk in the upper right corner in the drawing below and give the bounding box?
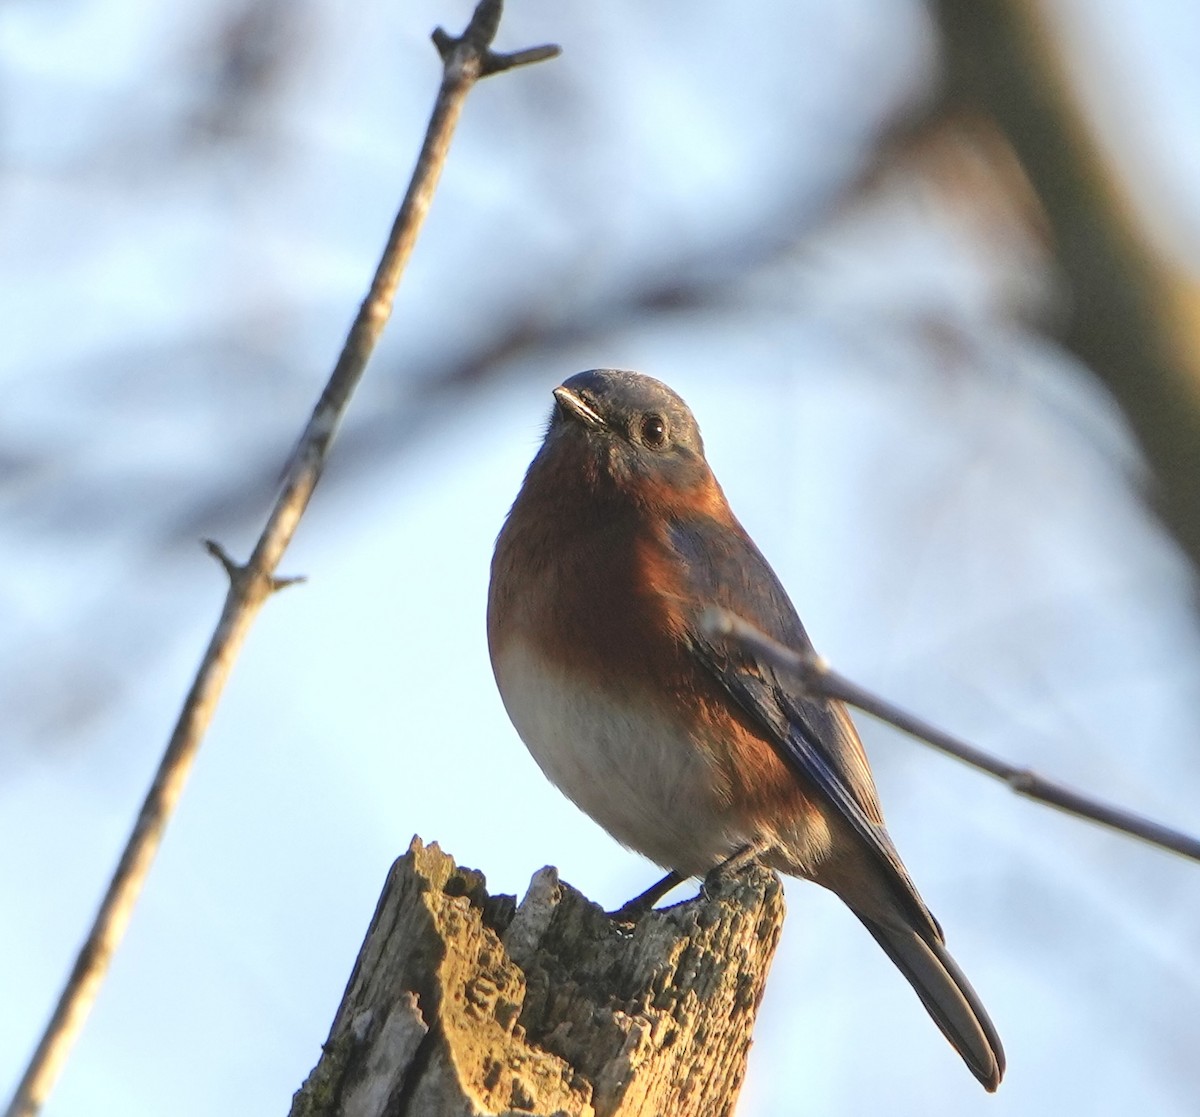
[931,0,1200,569]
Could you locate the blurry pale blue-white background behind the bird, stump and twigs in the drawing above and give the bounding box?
[0,0,1200,1117]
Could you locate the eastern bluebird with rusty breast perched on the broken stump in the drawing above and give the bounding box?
[487,368,1004,1091]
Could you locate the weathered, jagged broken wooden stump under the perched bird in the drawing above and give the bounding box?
[292,839,784,1117]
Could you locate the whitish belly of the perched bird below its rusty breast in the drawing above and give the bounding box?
[493,639,739,876]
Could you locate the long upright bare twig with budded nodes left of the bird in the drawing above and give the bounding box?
[6,0,558,1117]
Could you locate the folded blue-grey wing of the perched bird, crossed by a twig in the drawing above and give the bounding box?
[668,518,941,938]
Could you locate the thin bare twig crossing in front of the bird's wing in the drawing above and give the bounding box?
[703,607,1200,860]
